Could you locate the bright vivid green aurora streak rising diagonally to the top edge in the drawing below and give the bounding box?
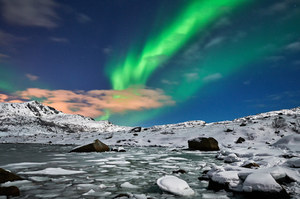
[108,0,248,90]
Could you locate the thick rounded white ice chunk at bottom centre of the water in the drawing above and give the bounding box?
[156,175,195,196]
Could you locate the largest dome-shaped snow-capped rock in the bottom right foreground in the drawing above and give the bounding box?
[243,172,282,192]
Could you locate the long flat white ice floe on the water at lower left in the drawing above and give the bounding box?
[18,167,86,175]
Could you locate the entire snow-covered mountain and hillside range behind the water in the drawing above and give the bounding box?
[0,101,300,148]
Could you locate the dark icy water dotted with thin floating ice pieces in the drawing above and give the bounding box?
[0,144,232,199]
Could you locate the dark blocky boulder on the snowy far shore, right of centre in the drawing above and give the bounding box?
[188,137,220,151]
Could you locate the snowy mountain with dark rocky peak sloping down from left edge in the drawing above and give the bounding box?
[0,101,130,142]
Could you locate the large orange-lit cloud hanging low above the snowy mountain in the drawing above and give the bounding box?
[0,88,175,117]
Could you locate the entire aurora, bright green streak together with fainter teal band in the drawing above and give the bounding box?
[105,1,300,124]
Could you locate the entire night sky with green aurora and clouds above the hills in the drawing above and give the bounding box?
[0,0,300,126]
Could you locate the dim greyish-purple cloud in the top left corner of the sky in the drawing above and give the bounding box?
[1,0,59,28]
